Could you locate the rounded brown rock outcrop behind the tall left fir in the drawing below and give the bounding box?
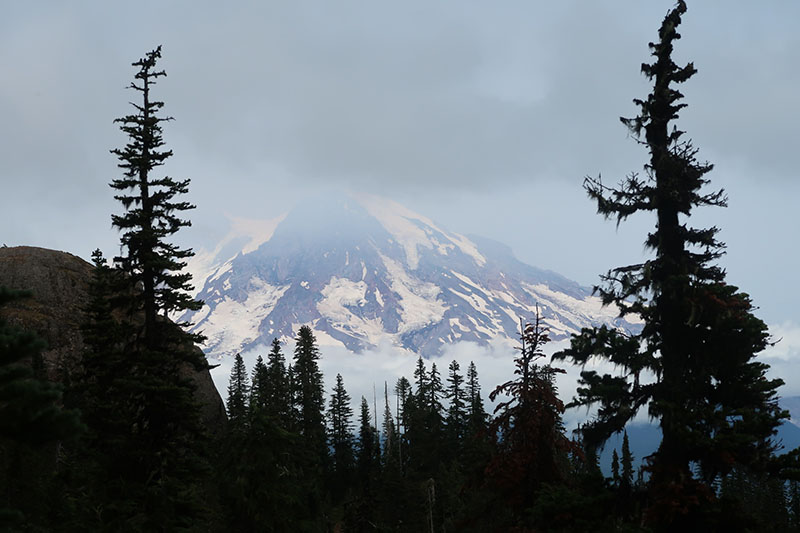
[0,246,225,431]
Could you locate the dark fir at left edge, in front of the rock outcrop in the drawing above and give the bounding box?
[0,287,82,531]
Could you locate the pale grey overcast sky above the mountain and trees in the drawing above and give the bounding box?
[0,0,800,378]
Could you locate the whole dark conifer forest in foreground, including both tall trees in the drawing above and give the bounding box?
[0,1,800,532]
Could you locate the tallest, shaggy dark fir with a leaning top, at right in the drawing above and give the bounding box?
[559,0,786,529]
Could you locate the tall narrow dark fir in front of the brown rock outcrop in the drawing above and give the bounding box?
[86,47,208,530]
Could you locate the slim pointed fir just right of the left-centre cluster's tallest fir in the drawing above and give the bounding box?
[328,374,355,501]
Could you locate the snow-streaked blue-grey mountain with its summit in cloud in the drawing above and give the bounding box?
[182,194,637,357]
